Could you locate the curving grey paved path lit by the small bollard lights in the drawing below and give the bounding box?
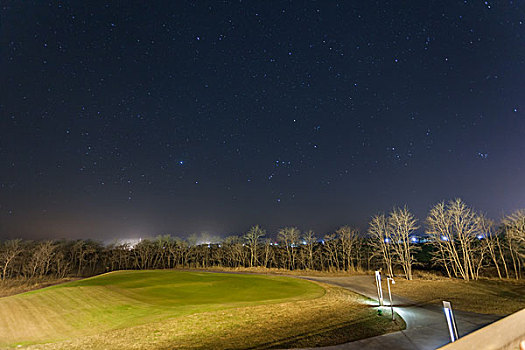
[298,276,501,350]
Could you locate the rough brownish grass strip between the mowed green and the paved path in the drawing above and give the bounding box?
[26,284,404,349]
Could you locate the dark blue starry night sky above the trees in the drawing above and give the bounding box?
[0,0,525,240]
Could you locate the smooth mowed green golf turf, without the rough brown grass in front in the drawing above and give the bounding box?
[0,270,325,347]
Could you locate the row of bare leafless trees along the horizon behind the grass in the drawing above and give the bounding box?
[0,199,525,280]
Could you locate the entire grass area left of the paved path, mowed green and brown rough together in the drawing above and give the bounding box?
[0,270,403,349]
